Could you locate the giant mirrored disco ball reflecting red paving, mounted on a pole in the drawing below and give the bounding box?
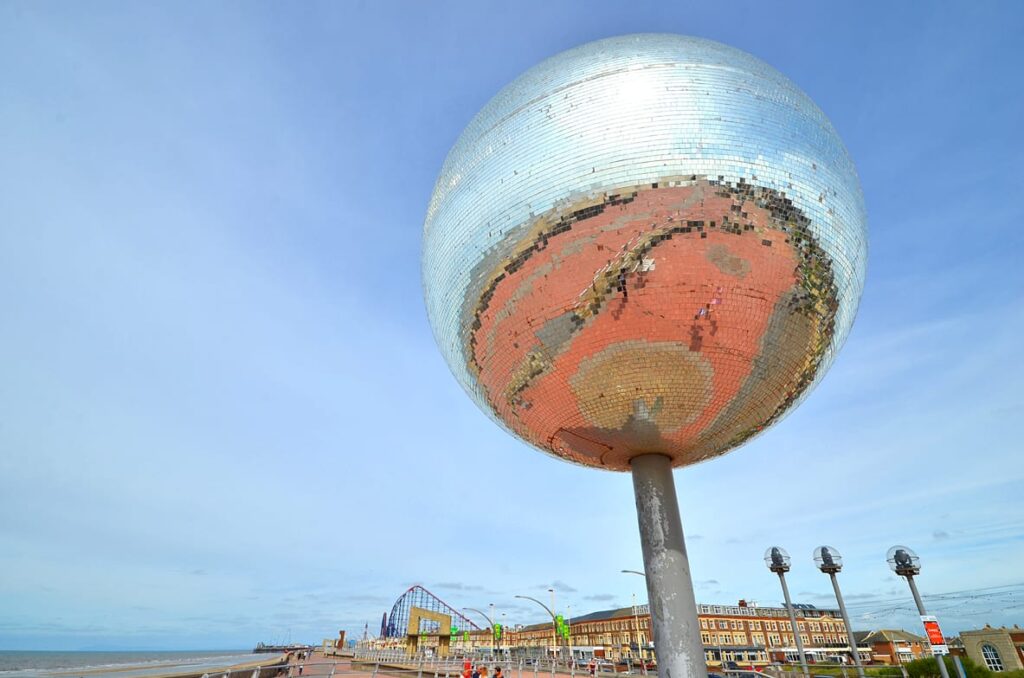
[423,35,867,470]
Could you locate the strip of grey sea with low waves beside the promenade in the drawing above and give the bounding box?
[0,649,278,678]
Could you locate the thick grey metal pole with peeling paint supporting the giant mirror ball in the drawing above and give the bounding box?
[630,454,708,678]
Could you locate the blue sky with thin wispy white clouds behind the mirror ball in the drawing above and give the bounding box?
[0,2,1024,649]
